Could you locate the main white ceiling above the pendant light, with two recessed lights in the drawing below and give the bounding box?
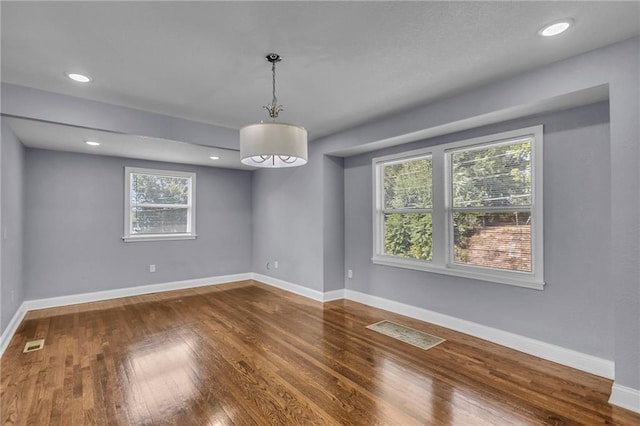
[0,1,640,165]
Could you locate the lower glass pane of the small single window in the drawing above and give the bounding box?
[131,206,189,234]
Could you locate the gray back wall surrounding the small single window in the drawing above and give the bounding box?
[25,149,252,300]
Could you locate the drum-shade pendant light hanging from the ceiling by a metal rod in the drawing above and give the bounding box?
[240,53,308,168]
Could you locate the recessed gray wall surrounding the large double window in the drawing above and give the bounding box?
[345,102,614,359]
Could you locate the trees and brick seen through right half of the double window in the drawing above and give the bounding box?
[448,139,532,272]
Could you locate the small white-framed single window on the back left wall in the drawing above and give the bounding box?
[123,167,196,241]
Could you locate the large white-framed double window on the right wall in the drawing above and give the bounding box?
[373,126,544,289]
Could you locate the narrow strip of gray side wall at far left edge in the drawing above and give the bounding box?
[0,120,25,334]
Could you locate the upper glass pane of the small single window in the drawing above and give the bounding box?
[131,173,190,206]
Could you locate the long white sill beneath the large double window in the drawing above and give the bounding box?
[371,256,545,290]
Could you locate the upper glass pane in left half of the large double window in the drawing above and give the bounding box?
[384,158,432,209]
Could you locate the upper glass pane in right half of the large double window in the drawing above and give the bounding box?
[451,141,531,207]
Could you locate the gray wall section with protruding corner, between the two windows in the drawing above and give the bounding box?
[253,142,344,292]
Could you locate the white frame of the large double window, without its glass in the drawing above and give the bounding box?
[371,125,545,290]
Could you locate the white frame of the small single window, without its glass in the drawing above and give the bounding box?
[122,167,197,242]
